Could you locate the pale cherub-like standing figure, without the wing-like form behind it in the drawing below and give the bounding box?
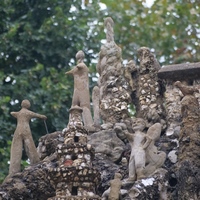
[125,118,146,182]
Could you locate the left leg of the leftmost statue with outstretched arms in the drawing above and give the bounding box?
[9,134,23,175]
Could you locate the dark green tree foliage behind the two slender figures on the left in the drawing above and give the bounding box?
[0,0,103,181]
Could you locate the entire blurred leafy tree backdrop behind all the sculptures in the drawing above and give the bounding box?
[0,0,200,180]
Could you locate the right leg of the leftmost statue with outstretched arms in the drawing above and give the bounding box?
[24,134,40,164]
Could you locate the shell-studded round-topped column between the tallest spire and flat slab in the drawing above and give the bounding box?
[136,47,165,125]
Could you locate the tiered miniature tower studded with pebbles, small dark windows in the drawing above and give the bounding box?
[49,106,100,200]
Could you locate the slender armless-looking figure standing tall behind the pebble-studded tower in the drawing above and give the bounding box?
[65,51,93,130]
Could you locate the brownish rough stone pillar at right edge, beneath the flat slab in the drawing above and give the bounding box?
[177,86,200,200]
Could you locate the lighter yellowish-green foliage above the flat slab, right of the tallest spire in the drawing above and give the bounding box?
[102,0,200,64]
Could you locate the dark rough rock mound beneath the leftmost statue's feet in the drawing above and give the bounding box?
[0,159,55,200]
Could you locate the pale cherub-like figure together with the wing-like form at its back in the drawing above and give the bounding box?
[125,118,166,182]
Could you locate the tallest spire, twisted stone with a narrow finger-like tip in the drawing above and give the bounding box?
[97,17,130,124]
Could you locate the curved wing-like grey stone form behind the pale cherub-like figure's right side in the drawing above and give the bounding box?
[143,123,166,177]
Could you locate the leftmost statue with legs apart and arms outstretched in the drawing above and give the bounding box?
[9,100,47,175]
